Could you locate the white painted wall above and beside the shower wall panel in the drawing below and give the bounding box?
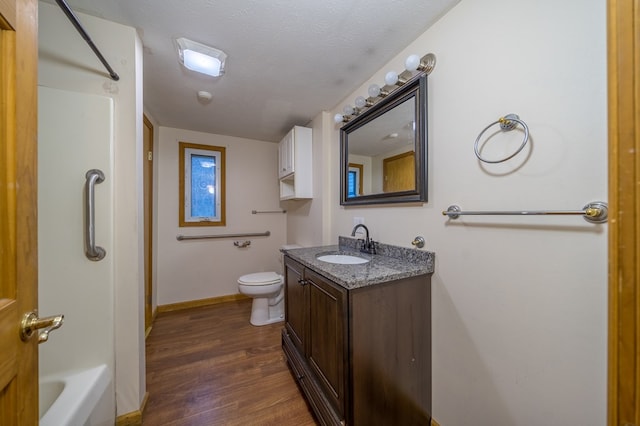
[38,2,145,415]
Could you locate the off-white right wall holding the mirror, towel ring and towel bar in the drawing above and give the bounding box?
[298,0,607,426]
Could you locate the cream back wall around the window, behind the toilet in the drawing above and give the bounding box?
[156,127,286,305]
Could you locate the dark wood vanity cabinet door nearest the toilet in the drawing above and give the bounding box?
[284,257,309,354]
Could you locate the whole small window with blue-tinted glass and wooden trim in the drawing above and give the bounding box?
[179,142,225,226]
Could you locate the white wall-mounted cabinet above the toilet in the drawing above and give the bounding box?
[278,126,313,200]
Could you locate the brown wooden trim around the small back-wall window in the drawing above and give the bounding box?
[178,142,226,227]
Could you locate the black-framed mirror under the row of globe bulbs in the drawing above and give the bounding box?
[340,75,427,205]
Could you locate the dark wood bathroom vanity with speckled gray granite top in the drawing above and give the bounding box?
[282,237,435,426]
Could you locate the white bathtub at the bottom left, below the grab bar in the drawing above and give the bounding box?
[40,365,115,426]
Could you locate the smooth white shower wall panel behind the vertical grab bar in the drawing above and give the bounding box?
[38,87,115,375]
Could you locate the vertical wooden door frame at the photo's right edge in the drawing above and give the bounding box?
[607,0,640,426]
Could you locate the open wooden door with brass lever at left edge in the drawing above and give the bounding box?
[0,0,38,426]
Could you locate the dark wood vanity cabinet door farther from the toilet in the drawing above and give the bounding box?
[306,270,348,416]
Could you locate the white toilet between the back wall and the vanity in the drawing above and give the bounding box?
[238,244,300,326]
